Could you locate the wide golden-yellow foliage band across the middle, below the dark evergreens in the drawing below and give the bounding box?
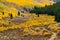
[0,14,59,36]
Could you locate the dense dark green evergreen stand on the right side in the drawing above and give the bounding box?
[30,2,60,22]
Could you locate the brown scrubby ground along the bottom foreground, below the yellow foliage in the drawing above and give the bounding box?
[0,29,60,40]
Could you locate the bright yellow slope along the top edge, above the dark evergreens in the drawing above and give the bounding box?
[7,0,54,6]
